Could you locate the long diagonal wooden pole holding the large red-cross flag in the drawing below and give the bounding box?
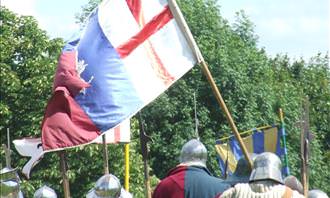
[168,0,253,169]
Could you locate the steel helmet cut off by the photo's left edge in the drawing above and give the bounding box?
[0,167,20,198]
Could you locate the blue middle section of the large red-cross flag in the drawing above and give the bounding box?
[75,11,143,132]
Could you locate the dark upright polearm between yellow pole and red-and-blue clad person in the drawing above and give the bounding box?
[138,112,151,198]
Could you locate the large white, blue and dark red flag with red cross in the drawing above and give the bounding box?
[42,0,196,152]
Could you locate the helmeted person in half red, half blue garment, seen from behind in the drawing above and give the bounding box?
[152,139,230,198]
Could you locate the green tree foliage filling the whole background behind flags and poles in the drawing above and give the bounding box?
[0,0,330,197]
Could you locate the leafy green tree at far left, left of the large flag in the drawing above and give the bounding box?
[0,7,63,197]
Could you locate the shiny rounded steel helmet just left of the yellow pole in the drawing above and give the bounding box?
[92,174,121,198]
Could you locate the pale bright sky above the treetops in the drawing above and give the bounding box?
[1,0,330,60]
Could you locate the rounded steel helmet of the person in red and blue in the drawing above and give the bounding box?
[180,139,207,167]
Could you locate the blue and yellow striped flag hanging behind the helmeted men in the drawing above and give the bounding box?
[215,126,289,179]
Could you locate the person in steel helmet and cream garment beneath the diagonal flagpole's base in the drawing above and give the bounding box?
[220,152,304,198]
